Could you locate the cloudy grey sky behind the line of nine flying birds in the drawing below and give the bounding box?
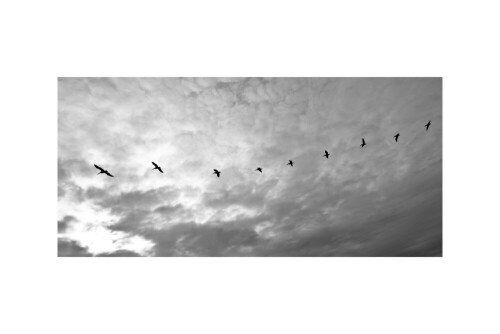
[57,78,442,257]
